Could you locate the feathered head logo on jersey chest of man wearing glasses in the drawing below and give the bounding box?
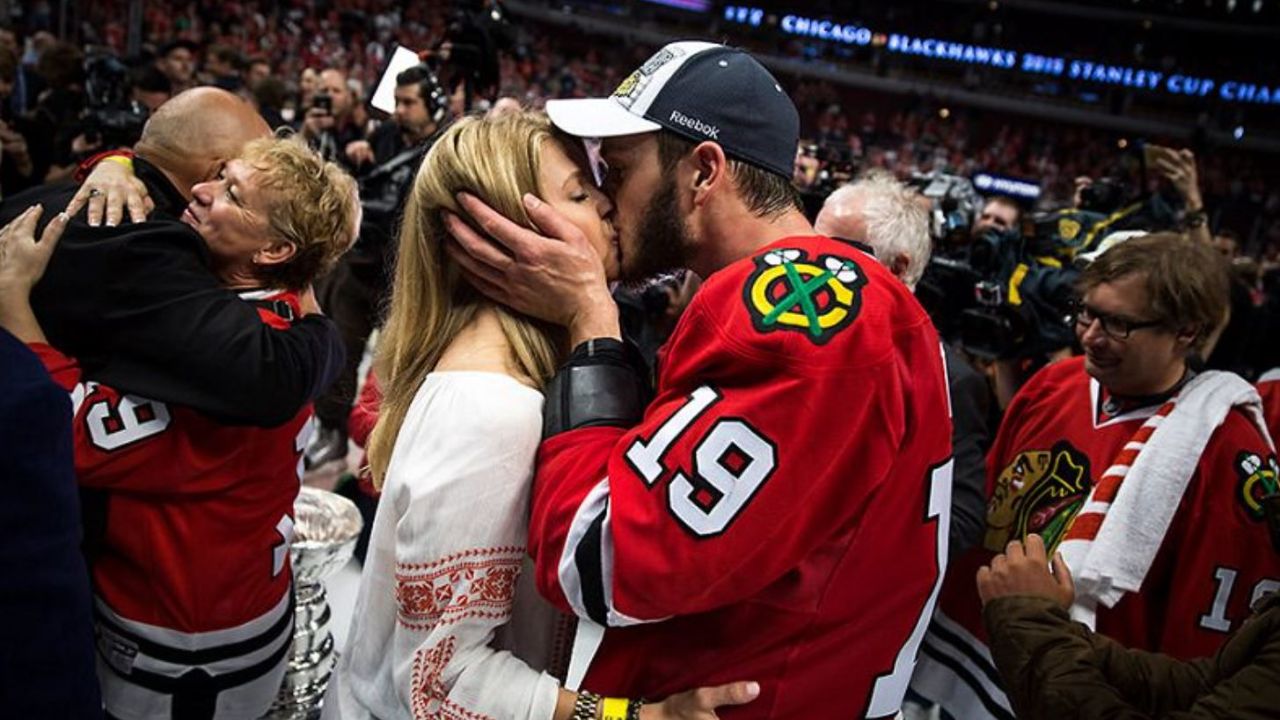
[983,441,1093,552]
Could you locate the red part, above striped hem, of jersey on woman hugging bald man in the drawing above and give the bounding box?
[32,285,311,634]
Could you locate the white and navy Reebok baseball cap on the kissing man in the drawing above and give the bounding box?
[547,41,800,179]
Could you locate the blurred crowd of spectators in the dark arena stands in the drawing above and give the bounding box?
[0,0,1264,252]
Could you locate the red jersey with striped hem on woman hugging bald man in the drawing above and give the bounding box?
[32,288,311,719]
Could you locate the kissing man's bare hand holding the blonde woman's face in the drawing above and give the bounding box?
[445,193,620,345]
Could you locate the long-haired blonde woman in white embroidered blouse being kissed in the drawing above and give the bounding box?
[325,113,750,720]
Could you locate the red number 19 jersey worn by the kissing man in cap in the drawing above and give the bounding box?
[530,237,951,719]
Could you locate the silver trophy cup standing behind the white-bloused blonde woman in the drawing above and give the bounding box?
[259,486,364,720]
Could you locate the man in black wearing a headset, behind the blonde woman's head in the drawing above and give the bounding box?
[306,65,448,468]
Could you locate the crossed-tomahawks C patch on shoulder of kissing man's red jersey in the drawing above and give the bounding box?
[742,250,867,345]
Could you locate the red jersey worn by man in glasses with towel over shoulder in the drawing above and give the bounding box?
[911,357,1280,719]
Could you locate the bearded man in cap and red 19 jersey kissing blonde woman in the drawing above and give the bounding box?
[451,42,950,719]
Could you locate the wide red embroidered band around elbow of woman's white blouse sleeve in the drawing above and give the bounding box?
[396,547,525,630]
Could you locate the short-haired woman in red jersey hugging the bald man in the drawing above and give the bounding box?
[0,140,358,720]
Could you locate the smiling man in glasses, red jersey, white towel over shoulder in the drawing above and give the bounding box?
[913,233,1280,719]
